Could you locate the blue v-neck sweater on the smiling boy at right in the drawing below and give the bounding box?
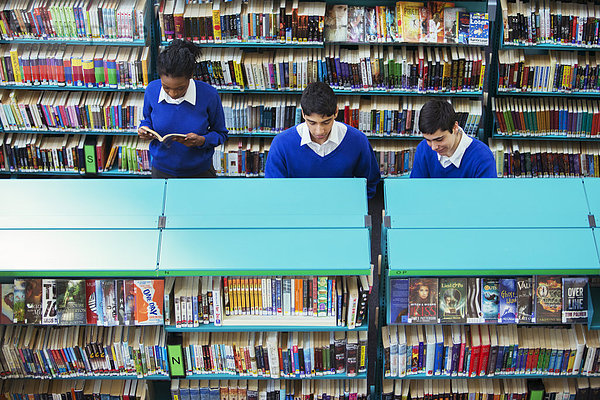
[410,138,498,178]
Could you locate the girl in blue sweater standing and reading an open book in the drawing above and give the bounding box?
[138,40,227,178]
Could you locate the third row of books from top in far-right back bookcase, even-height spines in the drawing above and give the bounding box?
[492,97,600,137]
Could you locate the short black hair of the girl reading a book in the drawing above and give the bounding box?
[156,39,201,78]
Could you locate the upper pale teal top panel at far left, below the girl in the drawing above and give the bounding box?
[0,179,165,229]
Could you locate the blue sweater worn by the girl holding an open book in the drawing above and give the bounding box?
[140,79,227,177]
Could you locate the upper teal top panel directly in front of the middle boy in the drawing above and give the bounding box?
[165,178,368,229]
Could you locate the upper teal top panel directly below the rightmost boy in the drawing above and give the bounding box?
[385,178,584,228]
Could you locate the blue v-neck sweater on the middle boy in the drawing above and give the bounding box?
[265,125,381,198]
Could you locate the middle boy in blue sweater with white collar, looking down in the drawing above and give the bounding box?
[265,82,381,198]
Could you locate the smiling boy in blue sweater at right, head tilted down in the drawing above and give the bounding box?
[410,100,498,178]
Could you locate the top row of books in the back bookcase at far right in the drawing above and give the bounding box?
[500,0,600,47]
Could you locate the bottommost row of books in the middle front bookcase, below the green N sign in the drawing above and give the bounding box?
[171,379,368,400]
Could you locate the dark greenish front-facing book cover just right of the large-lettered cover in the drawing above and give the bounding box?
[56,279,87,325]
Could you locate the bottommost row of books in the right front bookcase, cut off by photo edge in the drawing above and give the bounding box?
[381,378,600,400]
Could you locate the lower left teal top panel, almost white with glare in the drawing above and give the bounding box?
[0,229,160,277]
